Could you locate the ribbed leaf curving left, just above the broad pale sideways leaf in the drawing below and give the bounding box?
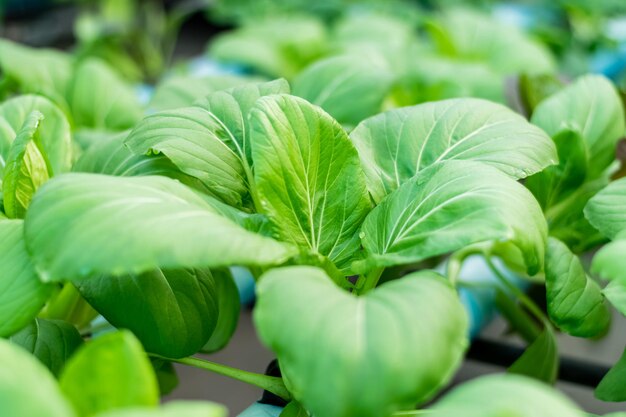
[125,106,248,206]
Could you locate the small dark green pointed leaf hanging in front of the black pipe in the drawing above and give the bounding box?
[508,327,559,385]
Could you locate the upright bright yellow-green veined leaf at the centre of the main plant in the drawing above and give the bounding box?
[250,95,370,266]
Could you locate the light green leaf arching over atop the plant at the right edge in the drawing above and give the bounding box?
[531,75,626,179]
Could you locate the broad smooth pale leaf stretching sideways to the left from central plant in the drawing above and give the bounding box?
[25,173,293,281]
